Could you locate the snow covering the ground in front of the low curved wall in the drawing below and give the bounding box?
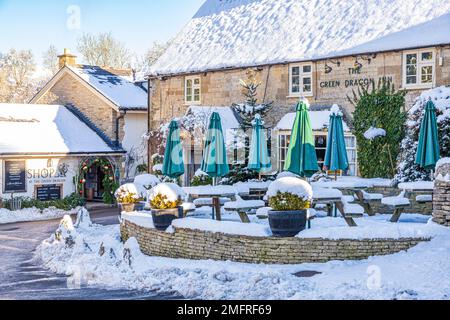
[36,210,450,300]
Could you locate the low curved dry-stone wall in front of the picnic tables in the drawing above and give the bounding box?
[121,220,429,264]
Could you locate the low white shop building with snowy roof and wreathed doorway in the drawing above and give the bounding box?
[0,104,125,201]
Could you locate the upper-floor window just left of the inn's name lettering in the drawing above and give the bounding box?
[289,64,313,96]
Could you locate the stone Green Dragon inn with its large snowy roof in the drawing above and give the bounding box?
[149,0,450,180]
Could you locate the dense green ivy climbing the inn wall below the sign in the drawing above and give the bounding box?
[348,79,406,178]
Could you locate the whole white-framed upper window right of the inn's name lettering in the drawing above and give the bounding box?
[403,50,435,88]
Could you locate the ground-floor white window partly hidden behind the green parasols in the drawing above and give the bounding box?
[278,133,357,176]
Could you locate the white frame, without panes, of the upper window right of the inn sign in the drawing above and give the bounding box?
[402,48,436,89]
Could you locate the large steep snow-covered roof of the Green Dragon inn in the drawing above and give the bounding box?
[150,0,450,75]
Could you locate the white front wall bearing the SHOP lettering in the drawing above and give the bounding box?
[0,157,80,199]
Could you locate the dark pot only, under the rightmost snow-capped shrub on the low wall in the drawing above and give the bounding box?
[269,210,308,237]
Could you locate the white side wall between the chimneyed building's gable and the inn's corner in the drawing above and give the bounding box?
[122,113,148,178]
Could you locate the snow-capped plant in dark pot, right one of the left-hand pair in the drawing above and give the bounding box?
[148,183,186,230]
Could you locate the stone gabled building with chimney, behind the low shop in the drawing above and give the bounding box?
[30,49,148,179]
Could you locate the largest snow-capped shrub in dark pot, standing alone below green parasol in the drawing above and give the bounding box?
[267,177,313,237]
